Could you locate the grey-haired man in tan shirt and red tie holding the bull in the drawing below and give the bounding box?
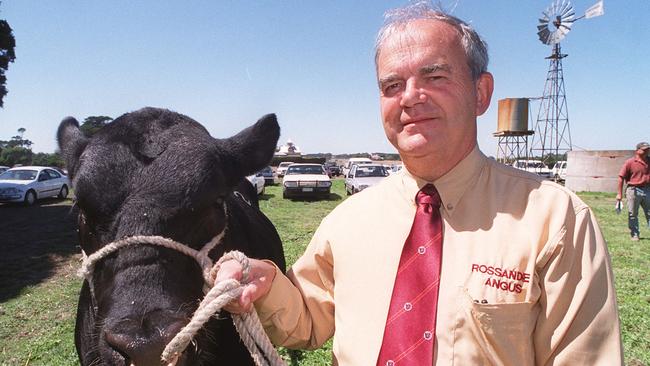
[217,3,622,366]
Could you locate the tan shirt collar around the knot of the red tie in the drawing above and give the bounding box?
[394,146,487,217]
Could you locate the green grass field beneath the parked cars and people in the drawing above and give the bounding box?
[0,180,650,366]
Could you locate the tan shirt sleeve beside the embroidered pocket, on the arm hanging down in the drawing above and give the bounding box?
[533,206,623,365]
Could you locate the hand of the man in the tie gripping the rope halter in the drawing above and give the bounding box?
[215,258,275,314]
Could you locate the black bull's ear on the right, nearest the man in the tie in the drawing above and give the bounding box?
[222,114,280,184]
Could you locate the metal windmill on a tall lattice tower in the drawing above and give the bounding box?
[530,0,604,161]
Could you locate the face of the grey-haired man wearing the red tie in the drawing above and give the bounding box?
[377,20,492,161]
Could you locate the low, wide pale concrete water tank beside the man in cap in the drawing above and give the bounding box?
[564,150,634,192]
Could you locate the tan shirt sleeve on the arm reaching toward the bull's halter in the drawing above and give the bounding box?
[255,222,334,349]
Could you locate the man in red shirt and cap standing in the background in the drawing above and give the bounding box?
[616,142,650,241]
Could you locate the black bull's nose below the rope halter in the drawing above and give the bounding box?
[104,312,187,366]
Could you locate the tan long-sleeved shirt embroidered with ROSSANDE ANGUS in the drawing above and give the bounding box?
[256,149,622,366]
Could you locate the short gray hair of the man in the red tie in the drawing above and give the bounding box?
[375,0,489,80]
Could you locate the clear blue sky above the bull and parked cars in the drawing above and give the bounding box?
[0,0,650,155]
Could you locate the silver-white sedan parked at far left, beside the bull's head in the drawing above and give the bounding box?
[0,166,70,205]
